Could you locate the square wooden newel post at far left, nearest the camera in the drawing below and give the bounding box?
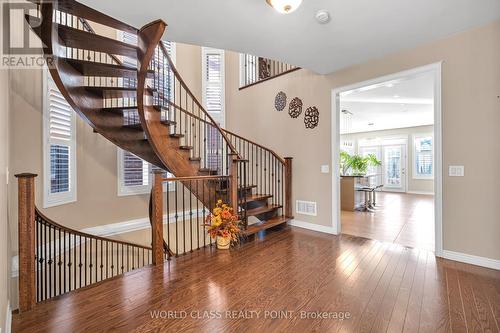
[16,173,37,312]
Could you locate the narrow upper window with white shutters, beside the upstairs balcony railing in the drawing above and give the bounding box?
[202,47,224,124]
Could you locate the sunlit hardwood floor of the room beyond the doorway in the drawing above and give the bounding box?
[341,192,434,251]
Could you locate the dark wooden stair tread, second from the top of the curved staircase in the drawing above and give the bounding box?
[56,24,138,59]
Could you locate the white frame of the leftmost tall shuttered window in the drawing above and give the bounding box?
[42,68,78,208]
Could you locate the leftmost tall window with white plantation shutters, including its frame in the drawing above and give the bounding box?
[43,71,76,207]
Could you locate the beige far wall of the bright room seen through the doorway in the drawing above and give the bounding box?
[340,125,434,193]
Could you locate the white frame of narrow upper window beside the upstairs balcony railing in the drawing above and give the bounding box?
[201,47,226,126]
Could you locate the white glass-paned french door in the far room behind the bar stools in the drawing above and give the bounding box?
[382,144,406,192]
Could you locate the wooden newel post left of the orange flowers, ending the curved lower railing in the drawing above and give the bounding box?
[151,171,163,265]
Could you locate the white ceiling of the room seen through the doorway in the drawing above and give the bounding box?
[340,73,434,134]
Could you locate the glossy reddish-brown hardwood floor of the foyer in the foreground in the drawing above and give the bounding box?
[13,227,500,332]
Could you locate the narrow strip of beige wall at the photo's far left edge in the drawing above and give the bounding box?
[0,69,11,330]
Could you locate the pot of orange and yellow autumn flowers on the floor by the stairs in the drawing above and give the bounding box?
[204,200,240,250]
